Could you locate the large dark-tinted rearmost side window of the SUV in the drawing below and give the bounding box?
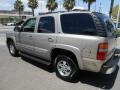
[61,13,97,35]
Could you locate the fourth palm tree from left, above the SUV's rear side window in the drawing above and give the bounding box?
[63,0,75,12]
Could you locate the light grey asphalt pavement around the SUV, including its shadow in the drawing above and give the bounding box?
[0,28,120,90]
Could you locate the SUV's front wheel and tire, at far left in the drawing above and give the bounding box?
[7,41,19,57]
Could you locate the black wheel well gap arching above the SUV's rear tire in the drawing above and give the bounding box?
[51,48,78,65]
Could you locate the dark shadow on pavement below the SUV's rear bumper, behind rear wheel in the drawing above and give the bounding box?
[75,66,119,90]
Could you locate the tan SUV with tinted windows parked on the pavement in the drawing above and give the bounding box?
[7,11,119,81]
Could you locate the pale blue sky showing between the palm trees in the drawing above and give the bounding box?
[0,0,120,15]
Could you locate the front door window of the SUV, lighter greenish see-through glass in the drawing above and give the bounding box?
[22,18,36,32]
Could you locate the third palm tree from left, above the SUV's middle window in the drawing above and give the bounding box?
[46,0,58,12]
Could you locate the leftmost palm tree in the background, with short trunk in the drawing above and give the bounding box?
[14,0,24,19]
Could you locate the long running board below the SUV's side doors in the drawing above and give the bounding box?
[19,52,51,66]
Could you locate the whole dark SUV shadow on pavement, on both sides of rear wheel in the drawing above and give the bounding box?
[22,57,119,90]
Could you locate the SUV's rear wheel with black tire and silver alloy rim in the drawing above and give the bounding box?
[54,55,79,82]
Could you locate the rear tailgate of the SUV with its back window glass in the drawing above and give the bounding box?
[94,13,117,62]
